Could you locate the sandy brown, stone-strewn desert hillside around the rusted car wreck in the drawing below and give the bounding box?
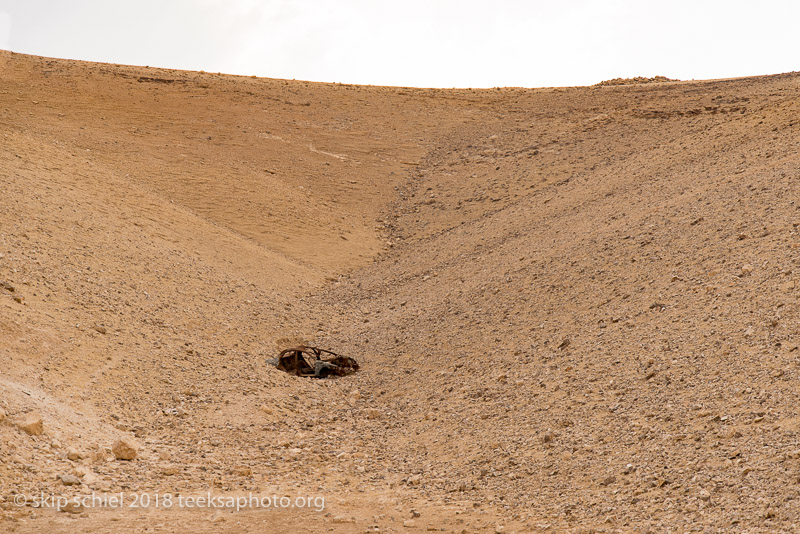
[0,52,800,533]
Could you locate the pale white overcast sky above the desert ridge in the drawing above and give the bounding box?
[0,0,800,87]
